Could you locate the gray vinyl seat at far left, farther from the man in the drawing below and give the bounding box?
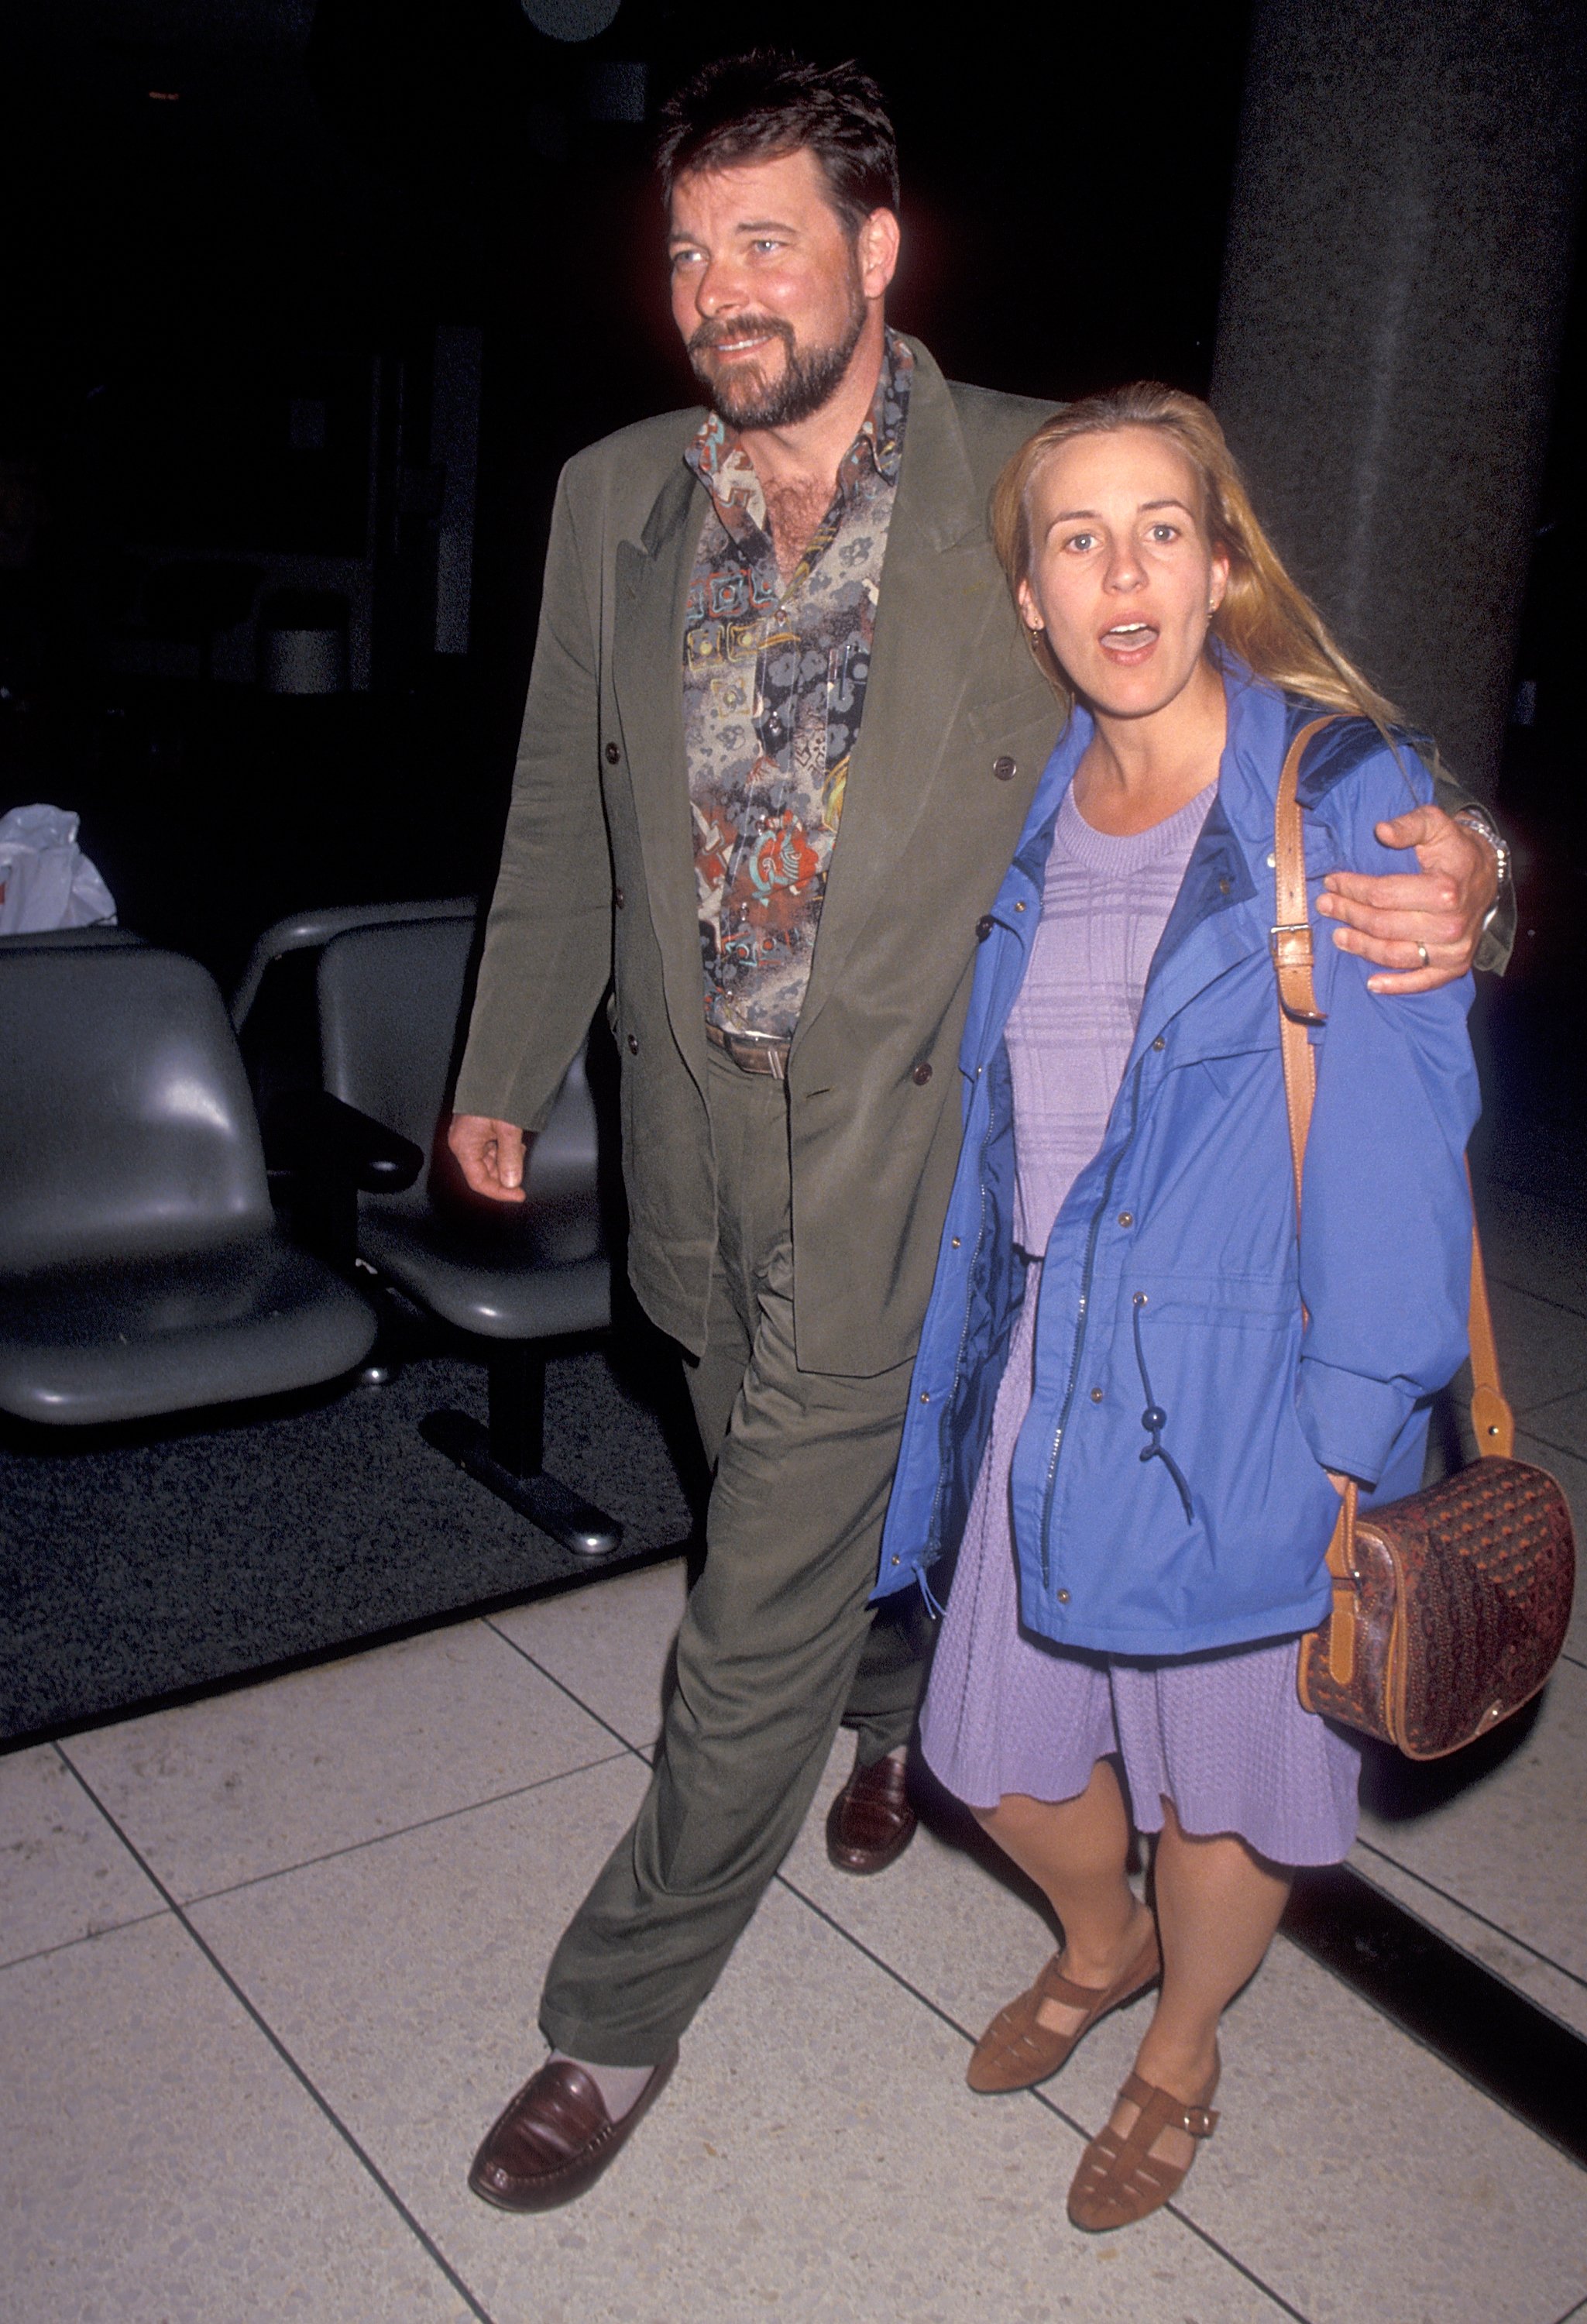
[0,944,374,1427]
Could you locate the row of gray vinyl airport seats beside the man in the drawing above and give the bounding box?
[0,897,623,1557]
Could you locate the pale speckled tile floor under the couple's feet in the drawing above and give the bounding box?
[12,1197,1587,2324]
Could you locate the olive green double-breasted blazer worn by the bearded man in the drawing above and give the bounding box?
[455,339,1496,1373]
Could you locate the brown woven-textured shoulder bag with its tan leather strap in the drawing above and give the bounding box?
[1273,718,1575,1759]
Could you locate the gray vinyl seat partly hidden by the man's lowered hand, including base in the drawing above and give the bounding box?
[318,904,623,1557]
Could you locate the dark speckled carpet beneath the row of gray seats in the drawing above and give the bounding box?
[0,1343,690,1741]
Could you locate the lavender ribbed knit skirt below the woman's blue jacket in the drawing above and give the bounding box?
[920,1267,1362,1864]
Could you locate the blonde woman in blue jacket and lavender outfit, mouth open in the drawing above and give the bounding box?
[881,386,1478,2229]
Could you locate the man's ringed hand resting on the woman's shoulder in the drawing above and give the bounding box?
[1317,806,1499,992]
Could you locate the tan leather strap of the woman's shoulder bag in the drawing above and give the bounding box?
[1269,718,1515,1685]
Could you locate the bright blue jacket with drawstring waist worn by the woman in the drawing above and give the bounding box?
[876,655,1478,1657]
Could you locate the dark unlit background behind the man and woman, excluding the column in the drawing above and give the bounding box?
[0,0,1585,974]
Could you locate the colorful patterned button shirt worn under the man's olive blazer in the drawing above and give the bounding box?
[683,332,913,1037]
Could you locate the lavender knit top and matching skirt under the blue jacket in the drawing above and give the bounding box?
[920,790,1359,1864]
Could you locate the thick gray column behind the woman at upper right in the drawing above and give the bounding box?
[1213,0,1587,790]
